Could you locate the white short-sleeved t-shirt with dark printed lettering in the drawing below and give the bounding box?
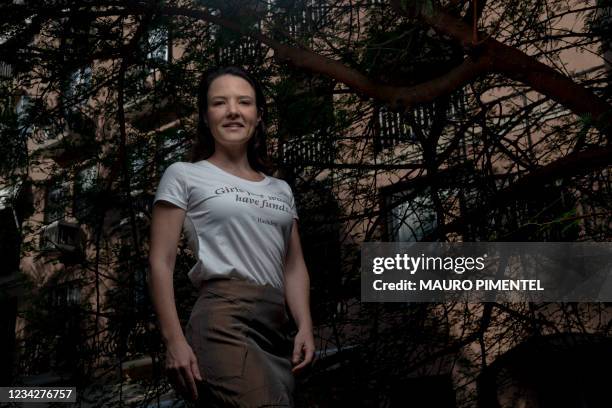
[153,160,298,289]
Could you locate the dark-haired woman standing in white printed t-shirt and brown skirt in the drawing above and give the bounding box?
[149,67,314,407]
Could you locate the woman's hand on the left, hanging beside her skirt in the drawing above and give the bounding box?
[166,338,202,401]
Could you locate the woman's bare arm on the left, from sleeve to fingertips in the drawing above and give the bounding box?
[149,201,202,399]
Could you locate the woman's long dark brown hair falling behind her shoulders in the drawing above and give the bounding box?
[191,66,271,174]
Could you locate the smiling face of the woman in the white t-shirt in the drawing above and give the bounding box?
[206,74,261,148]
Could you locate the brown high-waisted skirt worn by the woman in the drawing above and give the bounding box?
[185,279,294,408]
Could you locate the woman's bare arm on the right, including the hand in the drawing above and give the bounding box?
[285,220,314,372]
